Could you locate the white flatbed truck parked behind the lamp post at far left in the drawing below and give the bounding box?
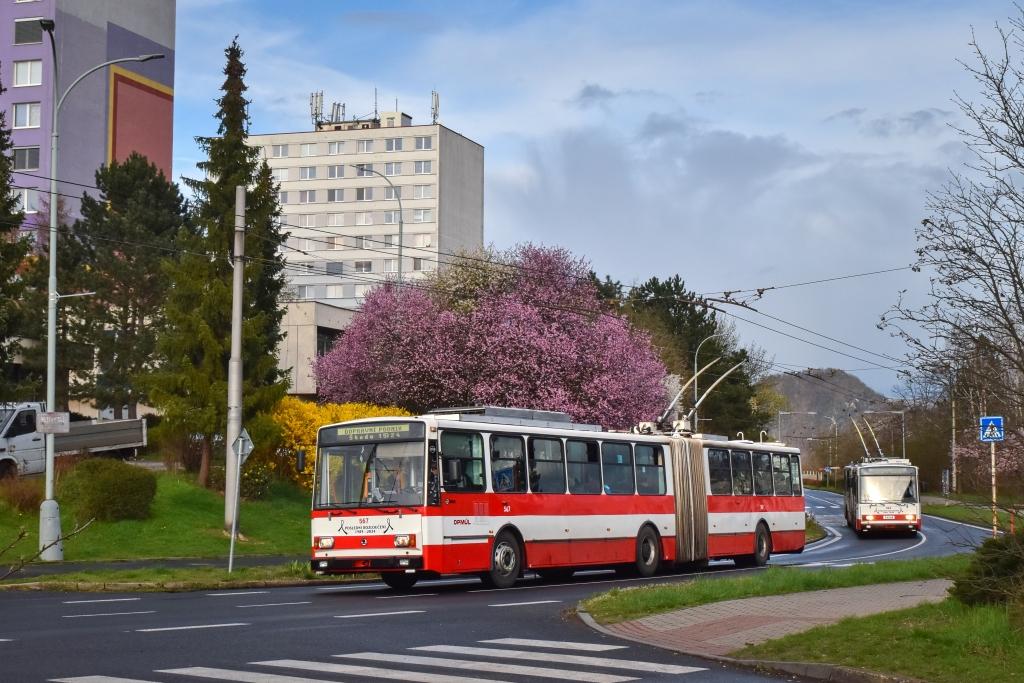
[0,402,146,479]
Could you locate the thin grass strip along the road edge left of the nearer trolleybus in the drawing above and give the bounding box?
[0,561,368,592]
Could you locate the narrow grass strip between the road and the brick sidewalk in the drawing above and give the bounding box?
[581,555,970,624]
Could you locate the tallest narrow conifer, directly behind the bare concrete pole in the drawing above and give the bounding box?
[148,38,287,485]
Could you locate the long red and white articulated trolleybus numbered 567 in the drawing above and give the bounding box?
[311,408,804,589]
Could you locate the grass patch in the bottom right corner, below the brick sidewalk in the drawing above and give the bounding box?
[730,598,1024,683]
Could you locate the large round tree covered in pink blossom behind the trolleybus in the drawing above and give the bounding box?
[314,246,667,428]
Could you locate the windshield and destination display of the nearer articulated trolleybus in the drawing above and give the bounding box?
[314,424,427,508]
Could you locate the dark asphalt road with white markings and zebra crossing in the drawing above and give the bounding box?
[0,492,985,683]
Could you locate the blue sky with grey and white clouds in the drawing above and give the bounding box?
[174,0,1015,394]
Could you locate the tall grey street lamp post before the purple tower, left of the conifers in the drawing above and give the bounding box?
[39,19,164,562]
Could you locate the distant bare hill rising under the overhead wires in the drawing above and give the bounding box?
[767,368,890,429]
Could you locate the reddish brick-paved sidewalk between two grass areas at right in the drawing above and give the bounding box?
[601,579,952,656]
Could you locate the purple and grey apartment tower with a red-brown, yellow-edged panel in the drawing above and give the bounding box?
[0,0,175,231]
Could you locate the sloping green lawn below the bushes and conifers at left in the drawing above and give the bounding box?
[0,473,309,561]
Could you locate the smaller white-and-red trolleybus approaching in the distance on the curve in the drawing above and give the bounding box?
[844,458,922,536]
